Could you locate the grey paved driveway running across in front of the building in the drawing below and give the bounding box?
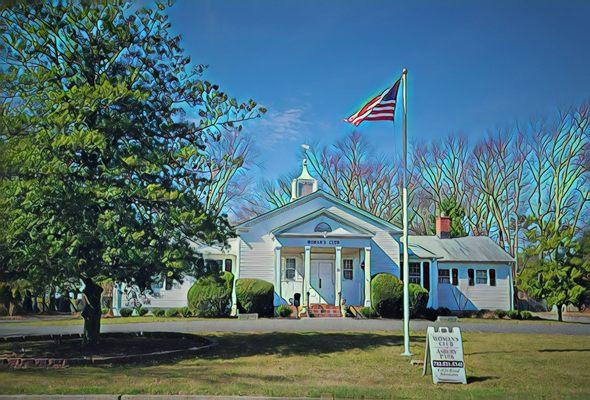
[0,318,590,336]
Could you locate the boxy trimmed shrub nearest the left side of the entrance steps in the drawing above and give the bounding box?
[236,278,275,317]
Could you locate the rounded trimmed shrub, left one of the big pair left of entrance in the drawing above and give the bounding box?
[187,272,234,317]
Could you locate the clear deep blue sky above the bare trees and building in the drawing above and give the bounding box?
[165,0,590,178]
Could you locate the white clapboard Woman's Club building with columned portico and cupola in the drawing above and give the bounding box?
[116,160,514,310]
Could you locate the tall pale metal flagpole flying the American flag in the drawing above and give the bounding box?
[402,68,412,356]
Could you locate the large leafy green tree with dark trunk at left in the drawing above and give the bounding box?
[0,0,264,344]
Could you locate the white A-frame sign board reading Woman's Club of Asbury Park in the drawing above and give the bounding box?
[422,326,467,384]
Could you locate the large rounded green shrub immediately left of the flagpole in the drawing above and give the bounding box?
[371,273,403,318]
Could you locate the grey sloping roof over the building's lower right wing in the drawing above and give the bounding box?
[408,236,514,263]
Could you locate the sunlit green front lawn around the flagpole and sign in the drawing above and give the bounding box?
[0,332,590,399]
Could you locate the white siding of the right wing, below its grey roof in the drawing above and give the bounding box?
[436,262,511,310]
